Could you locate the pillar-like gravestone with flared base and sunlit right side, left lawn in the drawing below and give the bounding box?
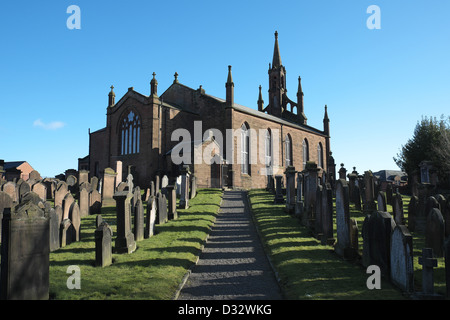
[114,191,136,253]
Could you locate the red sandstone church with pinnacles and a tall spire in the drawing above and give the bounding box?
[80,32,334,188]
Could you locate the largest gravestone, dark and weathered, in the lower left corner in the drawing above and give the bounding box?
[0,201,50,300]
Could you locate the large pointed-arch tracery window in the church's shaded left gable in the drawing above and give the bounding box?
[120,111,141,155]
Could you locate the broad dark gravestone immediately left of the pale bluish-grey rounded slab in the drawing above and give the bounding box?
[362,211,396,276]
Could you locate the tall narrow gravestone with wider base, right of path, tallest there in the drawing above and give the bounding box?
[334,179,355,259]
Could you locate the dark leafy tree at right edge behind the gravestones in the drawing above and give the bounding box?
[394,116,450,184]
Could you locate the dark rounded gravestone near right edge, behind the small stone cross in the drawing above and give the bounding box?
[425,208,445,257]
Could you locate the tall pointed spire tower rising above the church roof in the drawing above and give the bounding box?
[267,31,287,117]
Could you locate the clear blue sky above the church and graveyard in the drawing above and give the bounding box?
[0,0,450,176]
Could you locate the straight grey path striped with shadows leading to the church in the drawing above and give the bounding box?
[178,191,282,300]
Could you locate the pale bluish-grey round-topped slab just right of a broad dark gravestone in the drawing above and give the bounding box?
[390,225,414,293]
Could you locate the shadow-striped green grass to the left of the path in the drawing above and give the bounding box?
[50,189,222,300]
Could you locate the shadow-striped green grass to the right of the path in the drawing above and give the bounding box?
[249,189,445,300]
